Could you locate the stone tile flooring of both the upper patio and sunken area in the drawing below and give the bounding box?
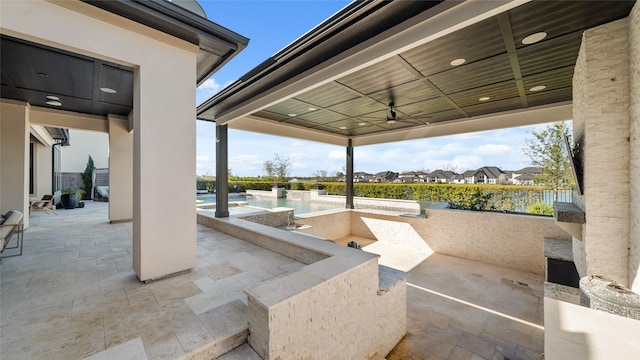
[0,202,543,360]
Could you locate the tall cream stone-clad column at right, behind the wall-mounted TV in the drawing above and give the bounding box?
[573,17,637,285]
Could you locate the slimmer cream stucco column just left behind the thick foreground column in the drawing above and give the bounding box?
[109,116,133,223]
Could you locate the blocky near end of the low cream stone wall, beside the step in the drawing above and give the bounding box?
[246,258,406,359]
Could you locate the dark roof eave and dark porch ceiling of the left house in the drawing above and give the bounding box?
[0,0,248,119]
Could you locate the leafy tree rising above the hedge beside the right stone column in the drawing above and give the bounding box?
[522,121,574,201]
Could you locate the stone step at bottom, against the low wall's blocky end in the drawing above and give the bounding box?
[181,300,249,360]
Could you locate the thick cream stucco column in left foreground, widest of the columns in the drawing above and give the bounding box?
[133,57,197,281]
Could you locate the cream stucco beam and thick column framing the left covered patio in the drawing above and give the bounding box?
[0,0,199,280]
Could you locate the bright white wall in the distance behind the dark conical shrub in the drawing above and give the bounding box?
[60,129,109,173]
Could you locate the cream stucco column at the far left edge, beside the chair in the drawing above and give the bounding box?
[0,101,29,228]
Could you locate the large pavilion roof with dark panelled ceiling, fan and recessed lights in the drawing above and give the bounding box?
[197,0,634,145]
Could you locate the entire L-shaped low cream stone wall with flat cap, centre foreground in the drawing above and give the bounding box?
[198,214,407,359]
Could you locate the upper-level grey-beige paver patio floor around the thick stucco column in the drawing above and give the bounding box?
[0,201,303,360]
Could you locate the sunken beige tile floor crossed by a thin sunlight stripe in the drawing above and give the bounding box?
[387,250,544,360]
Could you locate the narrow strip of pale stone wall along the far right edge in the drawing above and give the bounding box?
[629,3,640,294]
